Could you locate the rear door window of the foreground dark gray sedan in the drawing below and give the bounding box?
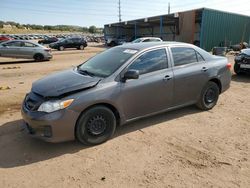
[171,47,197,66]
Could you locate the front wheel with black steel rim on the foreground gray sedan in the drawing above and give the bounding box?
[75,106,116,145]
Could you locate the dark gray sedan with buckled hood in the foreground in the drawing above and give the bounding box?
[22,42,231,145]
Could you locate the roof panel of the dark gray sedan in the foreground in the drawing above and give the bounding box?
[118,41,194,51]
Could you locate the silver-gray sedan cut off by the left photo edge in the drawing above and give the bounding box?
[0,40,52,61]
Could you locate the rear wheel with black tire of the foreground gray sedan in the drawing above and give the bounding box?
[196,81,220,110]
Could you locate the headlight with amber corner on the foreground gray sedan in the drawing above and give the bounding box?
[37,99,74,113]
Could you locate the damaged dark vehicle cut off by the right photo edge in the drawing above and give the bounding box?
[234,48,250,74]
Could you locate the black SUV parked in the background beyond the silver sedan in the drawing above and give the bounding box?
[49,38,88,51]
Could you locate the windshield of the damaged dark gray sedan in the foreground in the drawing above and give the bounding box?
[78,47,138,77]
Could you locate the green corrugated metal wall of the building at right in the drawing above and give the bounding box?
[200,8,250,51]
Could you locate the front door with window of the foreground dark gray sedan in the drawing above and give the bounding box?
[120,48,173,119]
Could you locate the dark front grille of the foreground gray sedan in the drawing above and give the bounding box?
[24,92,44,111]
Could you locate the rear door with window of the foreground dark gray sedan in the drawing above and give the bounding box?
[170,47,209,106]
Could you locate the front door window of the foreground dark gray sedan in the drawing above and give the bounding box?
[129,49,168,74]
